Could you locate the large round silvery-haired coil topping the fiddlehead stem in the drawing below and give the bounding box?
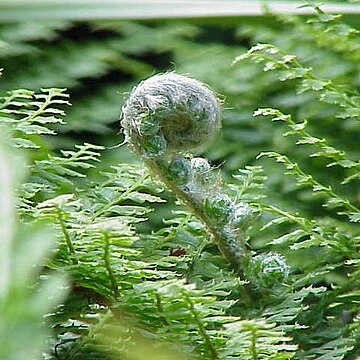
[121,72,220,158]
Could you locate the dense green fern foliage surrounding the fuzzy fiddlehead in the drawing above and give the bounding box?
[0,3,360,360]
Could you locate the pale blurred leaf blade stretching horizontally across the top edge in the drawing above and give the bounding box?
[0,0,360,22]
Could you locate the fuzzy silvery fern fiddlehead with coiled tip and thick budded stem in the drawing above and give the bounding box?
[121,73,286,286]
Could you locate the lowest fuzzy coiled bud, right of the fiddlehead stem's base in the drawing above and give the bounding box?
[247,252,289,289]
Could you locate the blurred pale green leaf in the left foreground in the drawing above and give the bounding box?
[0,131,65,359]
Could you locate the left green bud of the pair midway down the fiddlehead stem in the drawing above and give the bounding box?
[205,194,235,224]
